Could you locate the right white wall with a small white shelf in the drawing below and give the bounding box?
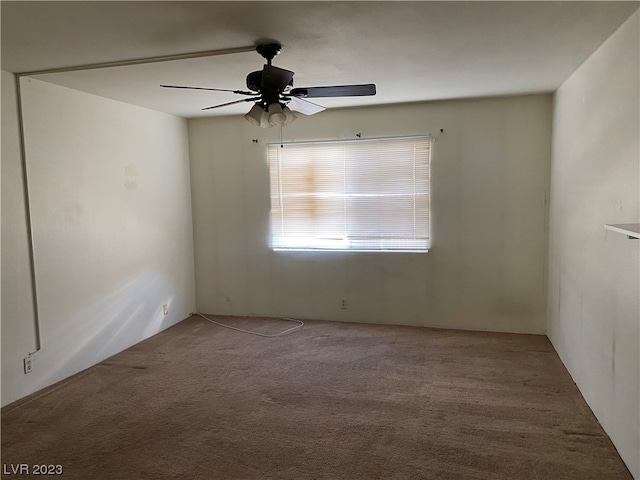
[548,12,640,479]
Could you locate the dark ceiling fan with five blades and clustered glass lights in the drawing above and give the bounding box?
[160,43,376,128]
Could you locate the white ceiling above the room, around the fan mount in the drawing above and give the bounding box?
[1,1,640,117]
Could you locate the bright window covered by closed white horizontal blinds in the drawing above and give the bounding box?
[268,136,431,251]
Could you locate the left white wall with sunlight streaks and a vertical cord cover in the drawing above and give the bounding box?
[2,72,195,405]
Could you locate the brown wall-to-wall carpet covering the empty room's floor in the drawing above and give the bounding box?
[2,317,631,480]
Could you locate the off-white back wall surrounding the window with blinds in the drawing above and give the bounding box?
[189,95,551,333]
